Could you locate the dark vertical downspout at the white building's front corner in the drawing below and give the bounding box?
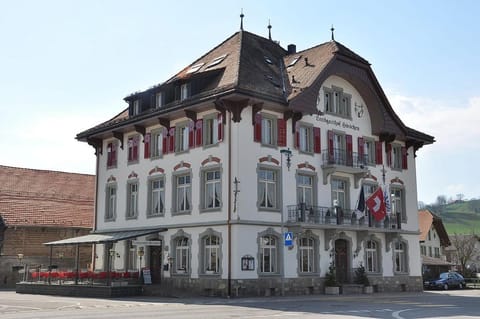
[227,112,232,298]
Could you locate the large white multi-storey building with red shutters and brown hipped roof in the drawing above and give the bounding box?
[77,25,434,296]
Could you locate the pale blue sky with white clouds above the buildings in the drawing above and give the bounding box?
[0,0,480,203]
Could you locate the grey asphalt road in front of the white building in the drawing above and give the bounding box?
[0,289,480,319]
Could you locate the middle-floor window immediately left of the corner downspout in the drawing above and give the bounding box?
[202,167,222,210]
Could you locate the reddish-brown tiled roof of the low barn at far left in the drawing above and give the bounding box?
[0,165,95,228]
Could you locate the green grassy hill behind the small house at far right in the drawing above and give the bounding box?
[427,199,480,235]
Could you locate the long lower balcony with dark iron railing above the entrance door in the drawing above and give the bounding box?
[287,203,401,230]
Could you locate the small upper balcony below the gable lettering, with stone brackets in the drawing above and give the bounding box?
[322,148,368,188]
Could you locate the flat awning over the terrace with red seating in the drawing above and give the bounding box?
[44,228,167,246]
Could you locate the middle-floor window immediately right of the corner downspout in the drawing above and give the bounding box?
[258,168,280,209]
